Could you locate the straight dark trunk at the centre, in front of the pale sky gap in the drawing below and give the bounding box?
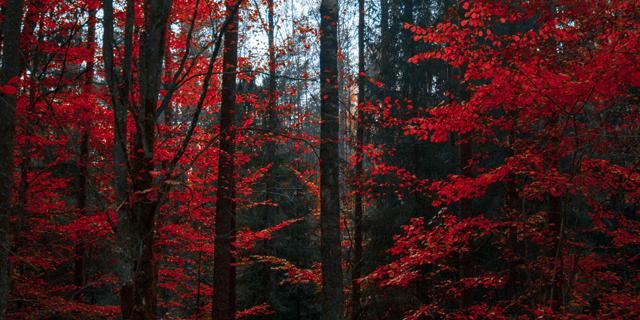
[320,0,344,320]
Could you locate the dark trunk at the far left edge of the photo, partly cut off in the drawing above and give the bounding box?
[0,0,23,320]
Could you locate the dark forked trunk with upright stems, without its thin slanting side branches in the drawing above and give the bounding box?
[103,0,172,320]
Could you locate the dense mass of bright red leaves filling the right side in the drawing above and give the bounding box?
[366,1,640,319]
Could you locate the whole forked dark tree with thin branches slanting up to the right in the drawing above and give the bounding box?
[104,1,249,319]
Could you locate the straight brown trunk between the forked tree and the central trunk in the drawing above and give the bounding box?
[212,0,238,320]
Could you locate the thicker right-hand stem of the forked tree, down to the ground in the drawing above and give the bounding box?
[131,0,172,320]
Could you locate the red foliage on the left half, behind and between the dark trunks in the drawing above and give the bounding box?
[5,0,314,319]
